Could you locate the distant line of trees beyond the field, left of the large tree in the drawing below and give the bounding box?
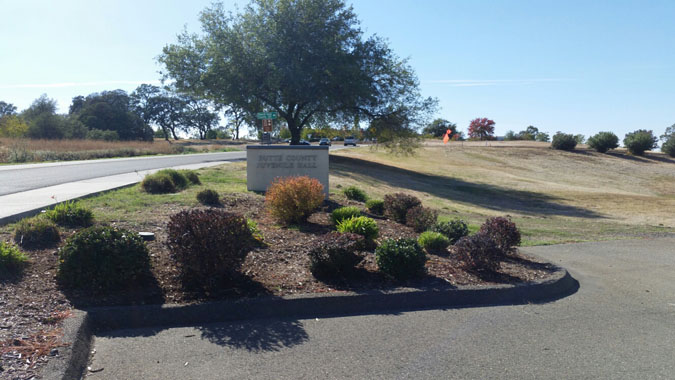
[0,84,256,141]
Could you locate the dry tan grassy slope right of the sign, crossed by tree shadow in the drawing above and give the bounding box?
[331,142,675,245]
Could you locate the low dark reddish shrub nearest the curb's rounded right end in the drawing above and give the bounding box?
[455,233,504,271]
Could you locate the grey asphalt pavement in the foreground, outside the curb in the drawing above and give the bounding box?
[87,237,675,379]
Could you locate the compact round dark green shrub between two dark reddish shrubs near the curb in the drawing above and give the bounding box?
[375,238,427,280]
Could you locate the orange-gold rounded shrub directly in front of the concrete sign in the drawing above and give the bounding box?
[265,176,324,224]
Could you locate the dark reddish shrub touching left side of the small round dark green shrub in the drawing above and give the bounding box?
[309,232,363,277]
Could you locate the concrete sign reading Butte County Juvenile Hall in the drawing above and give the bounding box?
[246,145,328,198]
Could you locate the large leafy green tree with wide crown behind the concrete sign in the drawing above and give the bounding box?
[159,0,436,144]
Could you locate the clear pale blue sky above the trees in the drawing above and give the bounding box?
[0,0,675,138]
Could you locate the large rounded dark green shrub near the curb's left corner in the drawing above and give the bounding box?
[58,226,150,293]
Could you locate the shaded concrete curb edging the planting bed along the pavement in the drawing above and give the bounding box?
[42,267,579,380]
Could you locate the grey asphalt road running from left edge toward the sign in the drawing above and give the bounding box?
[0,151,246,196]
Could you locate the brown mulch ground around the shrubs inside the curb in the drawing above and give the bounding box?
[0,194,553,379]
